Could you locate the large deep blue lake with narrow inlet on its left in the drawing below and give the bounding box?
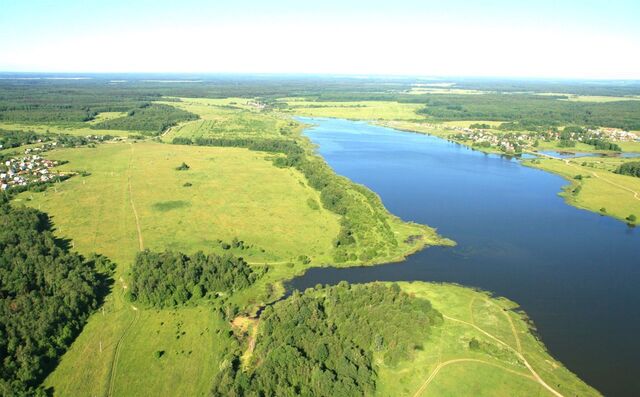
[289,118,640,396]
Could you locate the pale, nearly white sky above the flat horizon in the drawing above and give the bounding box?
[0,0,640,79]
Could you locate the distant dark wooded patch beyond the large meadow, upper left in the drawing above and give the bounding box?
[91,103,198,135]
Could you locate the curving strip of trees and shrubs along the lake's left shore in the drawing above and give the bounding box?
[173,137,398,262]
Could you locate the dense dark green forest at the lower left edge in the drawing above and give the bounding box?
[0,198,113,396]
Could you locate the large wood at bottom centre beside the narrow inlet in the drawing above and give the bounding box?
[212,282,442,396]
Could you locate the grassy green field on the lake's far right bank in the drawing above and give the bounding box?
[523,158,640,221]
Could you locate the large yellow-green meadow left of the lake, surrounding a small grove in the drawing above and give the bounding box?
[15,142,339,396]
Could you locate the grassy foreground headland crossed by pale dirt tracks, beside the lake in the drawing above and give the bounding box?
[377,282,600,397]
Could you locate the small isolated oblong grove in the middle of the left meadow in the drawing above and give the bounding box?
[131,250,261,307]
